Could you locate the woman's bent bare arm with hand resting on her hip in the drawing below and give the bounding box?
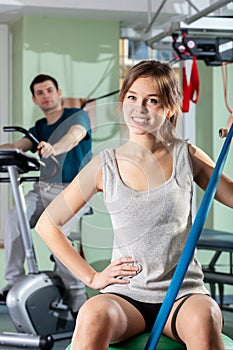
[36,157,138,289]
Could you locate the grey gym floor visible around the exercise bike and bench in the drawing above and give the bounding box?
[0,305,233,350]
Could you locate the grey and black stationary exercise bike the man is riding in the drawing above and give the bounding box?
[0,127,75,349]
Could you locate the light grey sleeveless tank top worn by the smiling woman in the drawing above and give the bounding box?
[101,140,209,303]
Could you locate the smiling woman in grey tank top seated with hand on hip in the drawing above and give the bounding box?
[36,60,233,350]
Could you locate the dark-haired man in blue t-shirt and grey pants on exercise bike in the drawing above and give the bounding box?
[0,74,92,313]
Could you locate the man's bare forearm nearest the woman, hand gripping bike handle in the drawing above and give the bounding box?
[38,125,87,158]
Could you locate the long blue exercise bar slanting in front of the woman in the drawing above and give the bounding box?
[145,124,233,350]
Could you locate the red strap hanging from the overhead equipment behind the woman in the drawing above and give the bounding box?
[182,56,200,112]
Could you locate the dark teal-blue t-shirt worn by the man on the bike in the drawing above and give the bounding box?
[29,108,92,183]
